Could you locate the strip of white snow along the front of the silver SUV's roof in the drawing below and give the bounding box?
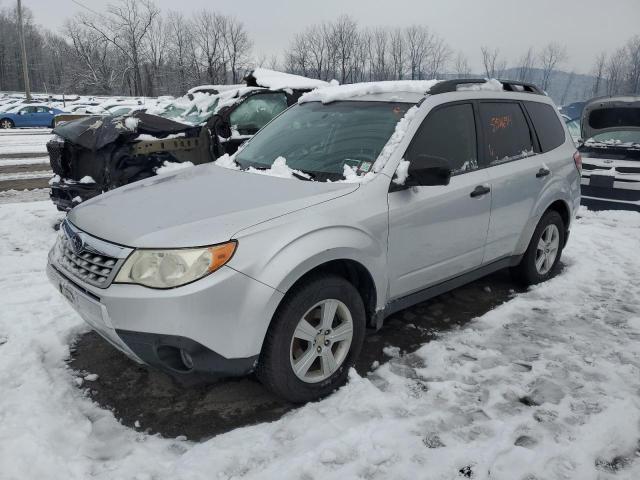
[298,80,440,103]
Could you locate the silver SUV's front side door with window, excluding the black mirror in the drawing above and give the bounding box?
[388,102,491,299]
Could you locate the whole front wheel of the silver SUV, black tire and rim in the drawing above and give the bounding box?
[257,274,366,403]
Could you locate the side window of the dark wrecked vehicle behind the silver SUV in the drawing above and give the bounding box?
[229,92,287,135]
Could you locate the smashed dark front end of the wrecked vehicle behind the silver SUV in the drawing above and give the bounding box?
[47,112,210,211]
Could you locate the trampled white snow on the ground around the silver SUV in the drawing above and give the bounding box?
[0,202,640,480]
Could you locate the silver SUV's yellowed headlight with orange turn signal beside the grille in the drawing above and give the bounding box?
[114,240,238,288]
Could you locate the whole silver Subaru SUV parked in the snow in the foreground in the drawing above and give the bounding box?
[47,80,580,402]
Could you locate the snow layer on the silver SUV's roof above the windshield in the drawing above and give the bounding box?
[298,80,440,103]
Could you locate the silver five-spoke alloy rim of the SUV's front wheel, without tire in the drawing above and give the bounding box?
[289,299,353,383]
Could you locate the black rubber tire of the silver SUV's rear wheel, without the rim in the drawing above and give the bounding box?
[511,210,566,286]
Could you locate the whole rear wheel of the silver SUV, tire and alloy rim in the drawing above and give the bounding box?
[511,210,565,285]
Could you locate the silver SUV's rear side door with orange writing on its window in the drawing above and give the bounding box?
[478,100,550,263]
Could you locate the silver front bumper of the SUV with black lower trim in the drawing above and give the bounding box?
[47,251,282,378]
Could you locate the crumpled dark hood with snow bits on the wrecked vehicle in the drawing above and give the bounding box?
[53,111,194,151]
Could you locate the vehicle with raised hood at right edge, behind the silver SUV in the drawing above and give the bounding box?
[579,96,640,211]
